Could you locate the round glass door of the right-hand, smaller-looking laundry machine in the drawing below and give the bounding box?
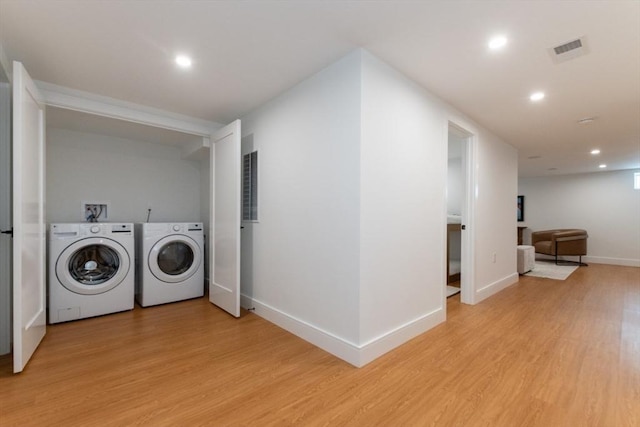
[148,234,202,283]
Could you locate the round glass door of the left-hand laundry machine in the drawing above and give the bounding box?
[56,237,130,295]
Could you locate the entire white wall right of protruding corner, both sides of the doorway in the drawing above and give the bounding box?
[360,52,518,364]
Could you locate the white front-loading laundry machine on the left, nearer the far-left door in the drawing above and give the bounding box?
[49,222,135,323]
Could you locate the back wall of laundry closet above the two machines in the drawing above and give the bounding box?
[47,128,201,222]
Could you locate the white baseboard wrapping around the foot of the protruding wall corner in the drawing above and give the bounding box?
[240,295,446,368]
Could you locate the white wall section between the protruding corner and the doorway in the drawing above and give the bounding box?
[360,52,447,364]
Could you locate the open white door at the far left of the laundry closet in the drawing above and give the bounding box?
[13,62,47,372]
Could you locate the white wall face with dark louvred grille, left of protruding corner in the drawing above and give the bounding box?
[241,51,360,348]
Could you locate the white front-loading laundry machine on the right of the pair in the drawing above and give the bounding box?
[136,222,204,307]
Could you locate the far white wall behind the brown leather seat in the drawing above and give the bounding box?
[518,170,640,267]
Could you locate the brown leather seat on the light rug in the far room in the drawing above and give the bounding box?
[531,228,589,265]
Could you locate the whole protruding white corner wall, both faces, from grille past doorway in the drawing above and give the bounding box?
[241,50,518,366]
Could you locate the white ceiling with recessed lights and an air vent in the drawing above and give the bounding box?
[0,0,640,176]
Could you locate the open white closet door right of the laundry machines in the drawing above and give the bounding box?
[209,120,241,317]
